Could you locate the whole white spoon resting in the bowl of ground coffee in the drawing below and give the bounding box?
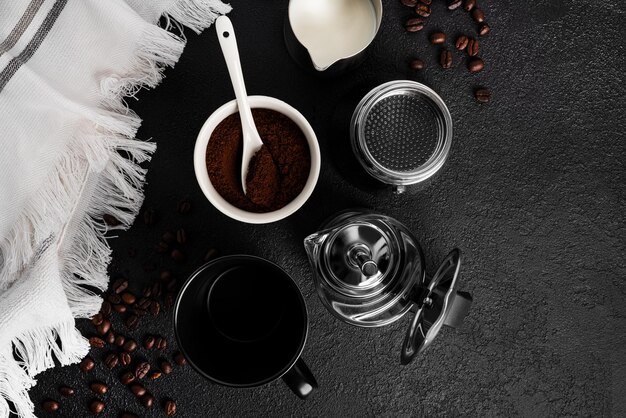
[215,16,263,193]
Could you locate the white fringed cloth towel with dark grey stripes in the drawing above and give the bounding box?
[0,0,230,417]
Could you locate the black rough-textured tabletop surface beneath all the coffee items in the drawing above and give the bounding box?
[31,0,626,417]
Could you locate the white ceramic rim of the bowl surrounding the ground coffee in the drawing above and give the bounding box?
[193,96,321,224]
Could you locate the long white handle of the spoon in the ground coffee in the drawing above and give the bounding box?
[215,16,256,132]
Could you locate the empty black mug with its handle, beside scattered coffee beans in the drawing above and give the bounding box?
[174,255,317,399]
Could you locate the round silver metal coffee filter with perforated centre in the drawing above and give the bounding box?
[351,80,452,191]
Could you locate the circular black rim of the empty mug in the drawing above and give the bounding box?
[172,254,309,388]
